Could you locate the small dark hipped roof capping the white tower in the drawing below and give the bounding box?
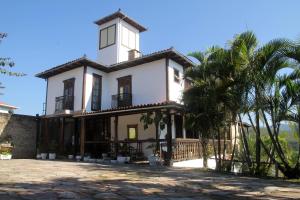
[95,9,147,32]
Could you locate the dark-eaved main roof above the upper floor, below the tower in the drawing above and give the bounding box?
[35,47,194,79]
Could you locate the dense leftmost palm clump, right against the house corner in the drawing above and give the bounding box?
[183,47,231,170]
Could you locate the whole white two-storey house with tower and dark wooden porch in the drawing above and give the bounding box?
[36,10,232,165]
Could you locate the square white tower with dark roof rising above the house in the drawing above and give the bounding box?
[95,10,146,65]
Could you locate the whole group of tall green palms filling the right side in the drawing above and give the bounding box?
[184,31,300,178]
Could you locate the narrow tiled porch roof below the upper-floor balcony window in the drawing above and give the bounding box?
[74,101,184,117]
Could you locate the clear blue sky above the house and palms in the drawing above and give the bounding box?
[0,0,300,115]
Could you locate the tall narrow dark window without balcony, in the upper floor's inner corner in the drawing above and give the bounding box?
[91,74,102,110]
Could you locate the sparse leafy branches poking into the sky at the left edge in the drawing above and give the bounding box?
[0,32,26,94]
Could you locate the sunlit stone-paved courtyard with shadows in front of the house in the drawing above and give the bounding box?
[0,160,300,200]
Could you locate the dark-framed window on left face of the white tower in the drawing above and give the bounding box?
[100,24,116,49]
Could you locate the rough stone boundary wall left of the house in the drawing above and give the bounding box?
[0,113,36,158]
